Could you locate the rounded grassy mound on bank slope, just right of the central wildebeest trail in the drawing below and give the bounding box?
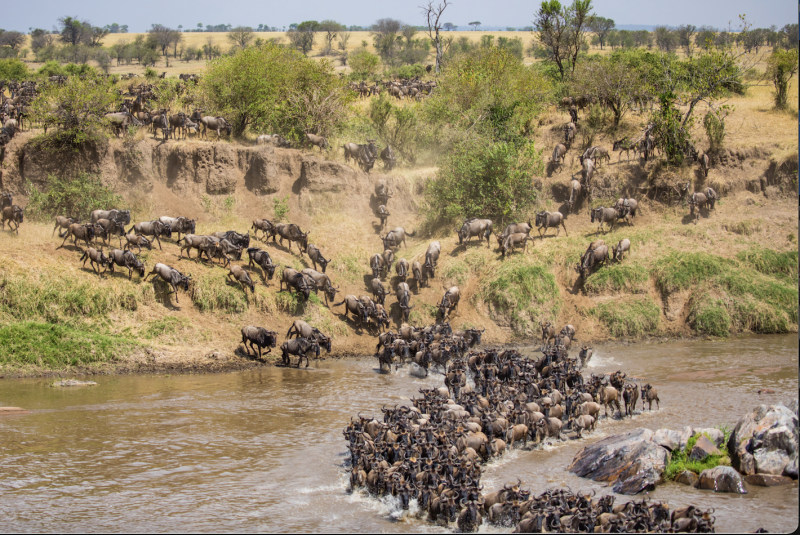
[479,255,562,334]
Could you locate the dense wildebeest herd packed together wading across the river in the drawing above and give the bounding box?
[343,323,692,533]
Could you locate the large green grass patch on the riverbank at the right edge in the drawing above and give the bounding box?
[655,249,798,335]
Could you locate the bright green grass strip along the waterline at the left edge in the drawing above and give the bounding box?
[0,322,138,369]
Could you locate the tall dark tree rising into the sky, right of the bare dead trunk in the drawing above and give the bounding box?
[533,0,594,79]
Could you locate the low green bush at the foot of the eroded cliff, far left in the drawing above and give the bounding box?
[27,173,122,221]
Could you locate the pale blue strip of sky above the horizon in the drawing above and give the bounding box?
[0,0,798,32]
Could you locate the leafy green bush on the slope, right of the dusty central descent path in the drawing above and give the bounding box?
[425,139,544,228]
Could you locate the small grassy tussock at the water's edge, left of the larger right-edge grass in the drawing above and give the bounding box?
[592,295,661,338]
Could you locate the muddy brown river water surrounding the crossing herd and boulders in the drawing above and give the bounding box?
[0,335,798,532]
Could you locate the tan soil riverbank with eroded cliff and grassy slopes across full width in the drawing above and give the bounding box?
[0,130,797,375]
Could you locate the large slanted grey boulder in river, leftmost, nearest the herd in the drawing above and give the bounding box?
[568,428,669,494]
